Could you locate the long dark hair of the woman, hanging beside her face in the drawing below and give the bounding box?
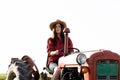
[51,24,64,45]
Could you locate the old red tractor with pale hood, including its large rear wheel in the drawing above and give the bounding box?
[6,28,120,80]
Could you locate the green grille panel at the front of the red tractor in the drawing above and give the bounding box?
[96,60,118,80]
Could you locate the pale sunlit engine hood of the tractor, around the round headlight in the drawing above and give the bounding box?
[58,50,101,67]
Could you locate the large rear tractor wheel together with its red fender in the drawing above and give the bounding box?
[6,56,40,80]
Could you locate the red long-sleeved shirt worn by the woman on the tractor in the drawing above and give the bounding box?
[47,37,73,64]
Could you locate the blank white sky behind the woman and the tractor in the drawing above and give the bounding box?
[0,0,120,73]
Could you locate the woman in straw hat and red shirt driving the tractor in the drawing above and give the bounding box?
[47,20,73,72]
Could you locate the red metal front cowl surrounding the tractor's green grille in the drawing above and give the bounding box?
[83,50,120,80]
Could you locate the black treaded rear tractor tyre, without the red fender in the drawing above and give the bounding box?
[6,60,39,80]
